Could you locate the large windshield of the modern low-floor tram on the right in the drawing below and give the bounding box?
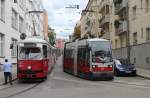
[91,42,112,63]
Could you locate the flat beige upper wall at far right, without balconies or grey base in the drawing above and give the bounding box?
[129,0,150,45]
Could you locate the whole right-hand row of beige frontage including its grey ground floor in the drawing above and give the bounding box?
[81,0,150,69]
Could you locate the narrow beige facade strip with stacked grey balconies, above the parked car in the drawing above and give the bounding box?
[111,0,129,49]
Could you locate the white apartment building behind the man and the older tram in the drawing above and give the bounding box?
[0,0,43,63]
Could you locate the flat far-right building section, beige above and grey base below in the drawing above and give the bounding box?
[129,0,150,69]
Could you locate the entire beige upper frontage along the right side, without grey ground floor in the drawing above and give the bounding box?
[81,0,150,49]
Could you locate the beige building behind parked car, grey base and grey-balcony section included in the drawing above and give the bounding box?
[112,0,150,69]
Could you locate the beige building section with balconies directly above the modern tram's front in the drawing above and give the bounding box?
[99,0,117,39]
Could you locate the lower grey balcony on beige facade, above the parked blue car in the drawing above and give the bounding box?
[116,21,127,35]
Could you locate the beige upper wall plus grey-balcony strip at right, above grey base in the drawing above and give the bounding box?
[111,0,150,49]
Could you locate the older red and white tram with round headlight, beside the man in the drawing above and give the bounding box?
[17,37,56,79]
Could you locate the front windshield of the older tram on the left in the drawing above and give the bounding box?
[19,47,42,59]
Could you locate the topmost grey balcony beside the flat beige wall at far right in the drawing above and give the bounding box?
[115,0,128,14]
